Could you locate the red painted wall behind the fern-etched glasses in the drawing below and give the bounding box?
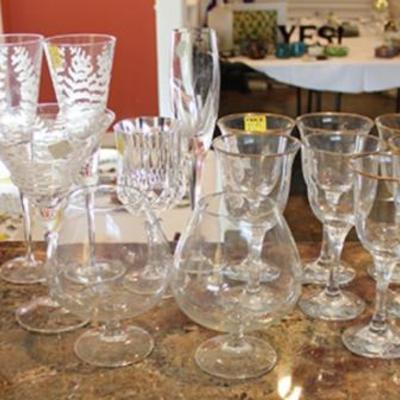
[2,0,158,118]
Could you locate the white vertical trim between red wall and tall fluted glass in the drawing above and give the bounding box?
[155,0,186,116]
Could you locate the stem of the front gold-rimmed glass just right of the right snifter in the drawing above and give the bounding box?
[325,224,351,297]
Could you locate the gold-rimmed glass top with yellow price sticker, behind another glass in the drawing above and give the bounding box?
[218,112,296,135]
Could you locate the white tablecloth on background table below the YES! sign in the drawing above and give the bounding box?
[229,37,400,93]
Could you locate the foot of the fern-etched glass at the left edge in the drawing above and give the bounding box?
[0,257,46,285]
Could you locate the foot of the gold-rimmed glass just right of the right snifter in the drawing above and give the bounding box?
[299,290,365,321]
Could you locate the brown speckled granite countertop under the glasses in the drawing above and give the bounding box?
[0,197,400,400]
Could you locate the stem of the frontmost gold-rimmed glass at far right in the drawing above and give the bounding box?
[369,254,396,333]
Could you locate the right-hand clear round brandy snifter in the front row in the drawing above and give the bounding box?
[171,192,301,379]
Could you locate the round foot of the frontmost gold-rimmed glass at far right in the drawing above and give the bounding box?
[342,325,400,360]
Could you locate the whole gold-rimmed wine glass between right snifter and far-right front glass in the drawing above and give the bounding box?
[299,133,381,321]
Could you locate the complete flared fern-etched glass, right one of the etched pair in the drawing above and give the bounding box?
[44,33,116,185]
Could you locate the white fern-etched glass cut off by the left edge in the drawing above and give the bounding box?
[0,33,44,284]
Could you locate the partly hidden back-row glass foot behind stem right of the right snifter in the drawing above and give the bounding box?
[303,259,356,286]
